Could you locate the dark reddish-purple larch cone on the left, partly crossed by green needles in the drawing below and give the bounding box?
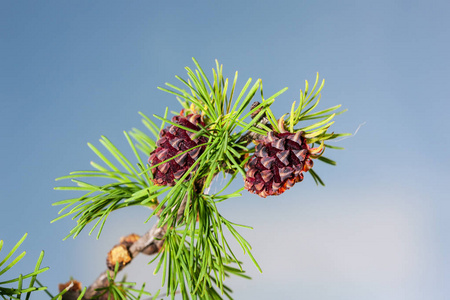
[149,114,208,186]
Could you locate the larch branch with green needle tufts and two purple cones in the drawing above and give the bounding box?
[52,60,348,299]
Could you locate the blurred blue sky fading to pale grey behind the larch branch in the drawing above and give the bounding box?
[0,0,450,300]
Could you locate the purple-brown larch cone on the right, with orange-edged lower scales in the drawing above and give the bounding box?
[245,131,313,198]
